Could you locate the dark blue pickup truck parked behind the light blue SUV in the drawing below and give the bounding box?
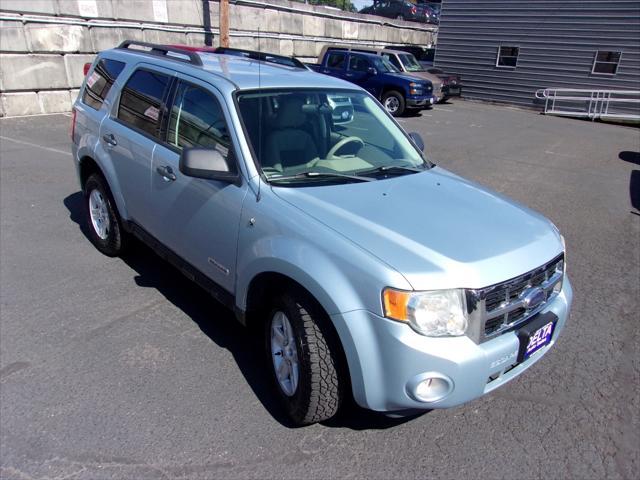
[307,49,437,117]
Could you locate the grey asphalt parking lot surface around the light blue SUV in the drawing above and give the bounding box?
[0,101,640,479]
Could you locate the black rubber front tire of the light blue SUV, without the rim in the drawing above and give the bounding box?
[265,289,346,426]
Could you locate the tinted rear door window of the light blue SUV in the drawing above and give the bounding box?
[118,70,170,138]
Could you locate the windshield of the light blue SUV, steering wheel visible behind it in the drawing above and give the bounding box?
[238,89,430,183]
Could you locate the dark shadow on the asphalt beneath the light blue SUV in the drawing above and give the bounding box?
[63,192,416,430]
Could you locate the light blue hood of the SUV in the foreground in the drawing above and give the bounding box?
[273,167,563,290]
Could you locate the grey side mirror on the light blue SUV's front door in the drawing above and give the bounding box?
[179,147,238,183]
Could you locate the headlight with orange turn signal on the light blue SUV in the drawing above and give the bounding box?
[382,288,468,337]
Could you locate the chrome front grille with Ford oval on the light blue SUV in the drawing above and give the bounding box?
[467,254,564,343]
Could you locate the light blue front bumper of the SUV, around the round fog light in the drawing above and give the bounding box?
[332,277,573,412]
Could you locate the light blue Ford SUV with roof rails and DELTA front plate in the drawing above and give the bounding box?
[72,42,572,425]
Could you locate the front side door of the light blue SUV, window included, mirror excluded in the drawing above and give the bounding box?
[148,76,248,292]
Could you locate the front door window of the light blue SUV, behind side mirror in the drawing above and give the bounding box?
[167,82,231,157]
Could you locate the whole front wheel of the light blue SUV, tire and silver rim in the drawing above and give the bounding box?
[265,289,344,426]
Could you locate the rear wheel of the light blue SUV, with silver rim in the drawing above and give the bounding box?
[84,173,127,257]
